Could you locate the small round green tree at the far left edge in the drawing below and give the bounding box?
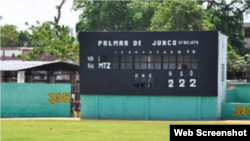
[0,24,19,47]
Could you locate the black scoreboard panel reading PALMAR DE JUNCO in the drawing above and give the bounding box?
[79,31,219,96]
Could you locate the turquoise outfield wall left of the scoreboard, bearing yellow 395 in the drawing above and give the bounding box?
[0,83,71,118]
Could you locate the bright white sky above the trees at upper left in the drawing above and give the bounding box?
[0,0,250,35]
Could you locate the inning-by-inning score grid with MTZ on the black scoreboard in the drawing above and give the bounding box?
[86,55,198,70]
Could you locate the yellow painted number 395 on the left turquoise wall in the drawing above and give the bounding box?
[48,93,70,104]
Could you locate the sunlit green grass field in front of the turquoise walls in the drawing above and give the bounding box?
[0,120,247,141]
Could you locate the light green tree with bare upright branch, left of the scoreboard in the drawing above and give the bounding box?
[18,0,79,61]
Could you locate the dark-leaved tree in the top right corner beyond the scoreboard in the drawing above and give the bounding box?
[198,0,250,55]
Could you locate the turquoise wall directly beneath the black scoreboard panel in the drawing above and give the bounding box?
[81,95,218,120]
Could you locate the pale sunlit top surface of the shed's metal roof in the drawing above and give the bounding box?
[0,61,79,71]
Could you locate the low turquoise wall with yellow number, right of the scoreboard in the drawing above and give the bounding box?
[221,103,250,120]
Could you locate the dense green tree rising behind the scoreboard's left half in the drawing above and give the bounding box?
[73,0,159,31]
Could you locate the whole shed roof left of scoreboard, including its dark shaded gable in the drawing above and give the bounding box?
[0,61,79,71]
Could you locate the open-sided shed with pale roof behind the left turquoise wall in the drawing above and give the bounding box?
[0,61,79,99]
